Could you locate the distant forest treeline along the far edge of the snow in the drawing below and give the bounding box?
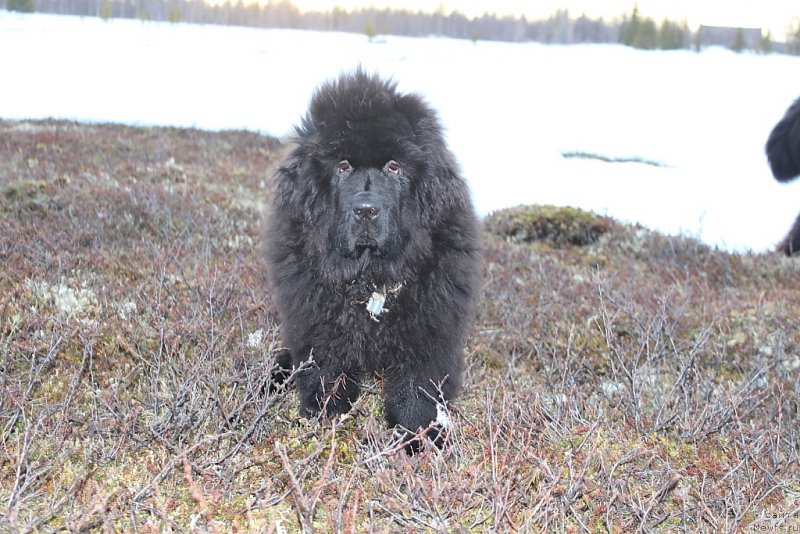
[0,0,800,54]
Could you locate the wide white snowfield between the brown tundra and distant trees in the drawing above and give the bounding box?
[0,11,800,252]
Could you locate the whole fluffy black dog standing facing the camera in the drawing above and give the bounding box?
[267,70,480,451]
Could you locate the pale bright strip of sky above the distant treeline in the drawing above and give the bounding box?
[292,0,800,37]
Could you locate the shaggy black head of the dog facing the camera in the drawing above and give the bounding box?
[278,69,471,281]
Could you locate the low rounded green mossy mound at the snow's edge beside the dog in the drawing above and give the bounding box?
[484,205,619,247]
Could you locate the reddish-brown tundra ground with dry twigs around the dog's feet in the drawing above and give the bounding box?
[0,121,800,532]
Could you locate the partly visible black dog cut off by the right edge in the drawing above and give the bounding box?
[766,98,800,256]
